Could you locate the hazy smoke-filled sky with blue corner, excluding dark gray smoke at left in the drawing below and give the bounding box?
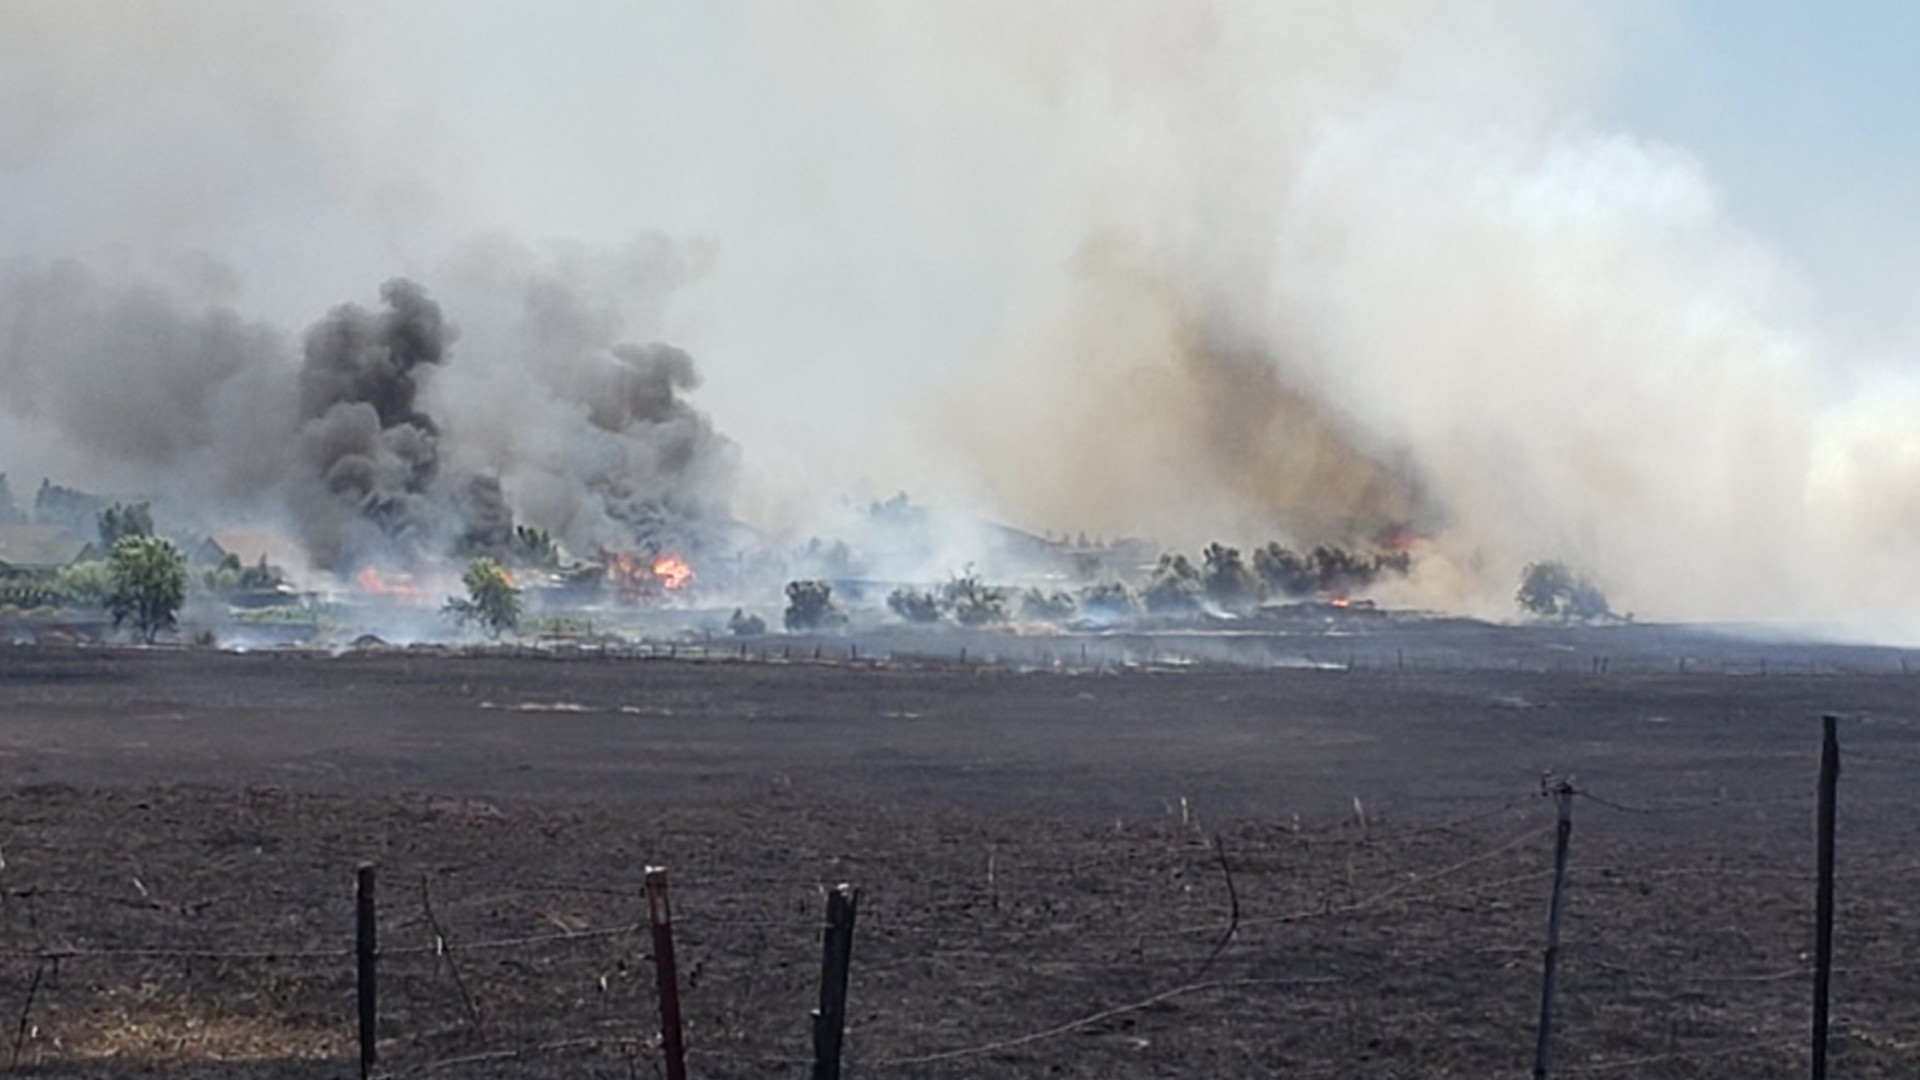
[11,0,1920,638]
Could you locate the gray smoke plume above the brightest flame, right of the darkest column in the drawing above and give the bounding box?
[444,236,737,555]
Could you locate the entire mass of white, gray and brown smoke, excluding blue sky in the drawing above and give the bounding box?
[11,0,1920,638]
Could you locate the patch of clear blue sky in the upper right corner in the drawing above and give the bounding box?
[1601,0,1920,336]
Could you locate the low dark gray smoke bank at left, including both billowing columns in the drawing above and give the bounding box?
[0,263,732,575]
